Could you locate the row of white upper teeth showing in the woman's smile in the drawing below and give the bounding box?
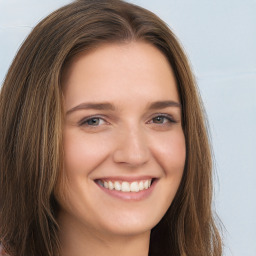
[98,179,152,192]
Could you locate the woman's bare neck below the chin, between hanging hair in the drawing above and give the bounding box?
[60,213,150,256]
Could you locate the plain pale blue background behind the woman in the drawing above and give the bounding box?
[0,0,256,256]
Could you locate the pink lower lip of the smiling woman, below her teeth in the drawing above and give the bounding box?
[96,180,158,201]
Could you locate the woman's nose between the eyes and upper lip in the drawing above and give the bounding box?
[113,127,150,167]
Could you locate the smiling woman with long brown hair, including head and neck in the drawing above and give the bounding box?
[0,0,222,256]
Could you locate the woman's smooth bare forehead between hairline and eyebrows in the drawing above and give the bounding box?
[62,42,179,107]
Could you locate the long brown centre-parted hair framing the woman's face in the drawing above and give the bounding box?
[0,0,222,256]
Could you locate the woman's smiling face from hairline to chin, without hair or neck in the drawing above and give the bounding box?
[56,42,186,239]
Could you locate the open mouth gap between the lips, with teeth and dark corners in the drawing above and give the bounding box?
[95,178,156,193]
